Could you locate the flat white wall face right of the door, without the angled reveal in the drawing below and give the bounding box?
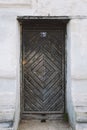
[70,19,87,130]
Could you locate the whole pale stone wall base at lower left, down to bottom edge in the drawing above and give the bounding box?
[0,92,15,130]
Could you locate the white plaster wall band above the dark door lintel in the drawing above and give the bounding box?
[0,0,87,16]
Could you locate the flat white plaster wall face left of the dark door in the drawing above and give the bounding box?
[0,12,20,129]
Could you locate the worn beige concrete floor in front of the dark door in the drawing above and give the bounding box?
[18,120,72,130]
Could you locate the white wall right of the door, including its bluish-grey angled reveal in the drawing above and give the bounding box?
[66,19,87,130]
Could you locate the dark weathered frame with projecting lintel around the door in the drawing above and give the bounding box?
[17,16,69,119]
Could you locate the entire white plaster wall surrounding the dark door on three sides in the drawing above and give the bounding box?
[0,0,87,130]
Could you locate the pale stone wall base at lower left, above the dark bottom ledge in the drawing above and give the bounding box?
[0,92,15,122]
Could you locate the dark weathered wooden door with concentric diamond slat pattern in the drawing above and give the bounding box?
[22,20,65,119]
